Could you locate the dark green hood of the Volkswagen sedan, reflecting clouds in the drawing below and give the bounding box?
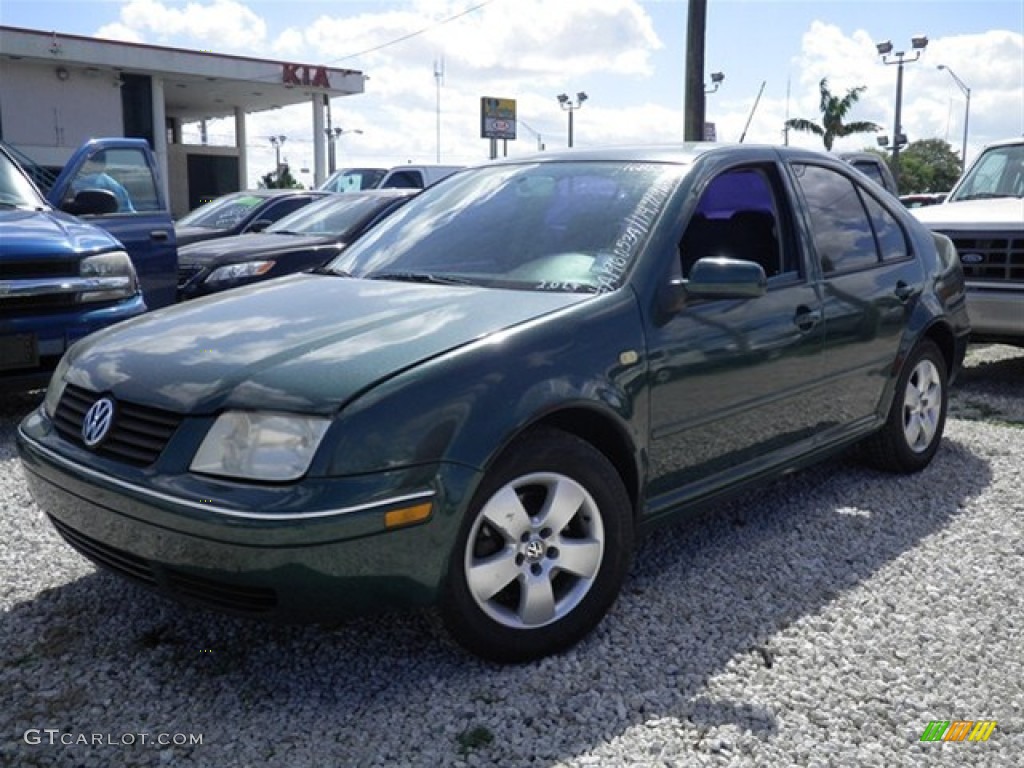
[67,274,592,414]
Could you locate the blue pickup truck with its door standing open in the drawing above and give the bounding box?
[0,138,177,390]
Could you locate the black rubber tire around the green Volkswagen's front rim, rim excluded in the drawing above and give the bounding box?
[440,429,633,663]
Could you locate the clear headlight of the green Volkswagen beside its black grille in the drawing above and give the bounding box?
[189,411,331,482]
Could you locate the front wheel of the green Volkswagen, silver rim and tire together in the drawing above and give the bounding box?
[441,429,633,662]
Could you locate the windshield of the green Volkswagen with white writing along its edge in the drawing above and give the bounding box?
[328,161,686,293]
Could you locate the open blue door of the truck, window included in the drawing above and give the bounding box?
[48,138,177,309]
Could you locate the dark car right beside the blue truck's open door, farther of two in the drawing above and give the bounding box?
[174,189,329,246]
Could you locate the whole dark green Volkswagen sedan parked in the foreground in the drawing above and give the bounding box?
[18,144,969,662]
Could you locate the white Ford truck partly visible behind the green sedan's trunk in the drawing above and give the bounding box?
[913,138,1024,346]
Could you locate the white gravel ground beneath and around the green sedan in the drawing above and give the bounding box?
[0,347,1024,768]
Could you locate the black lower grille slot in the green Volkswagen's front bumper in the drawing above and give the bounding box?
[50,516,278,615]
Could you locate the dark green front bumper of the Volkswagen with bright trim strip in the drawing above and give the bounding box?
[17,413,477,622]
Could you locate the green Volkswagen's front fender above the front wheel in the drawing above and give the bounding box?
[311,290,647,476]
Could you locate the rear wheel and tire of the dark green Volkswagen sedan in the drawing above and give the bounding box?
[863,339,949,472]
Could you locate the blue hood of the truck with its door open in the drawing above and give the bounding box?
[0,209,122,259]
